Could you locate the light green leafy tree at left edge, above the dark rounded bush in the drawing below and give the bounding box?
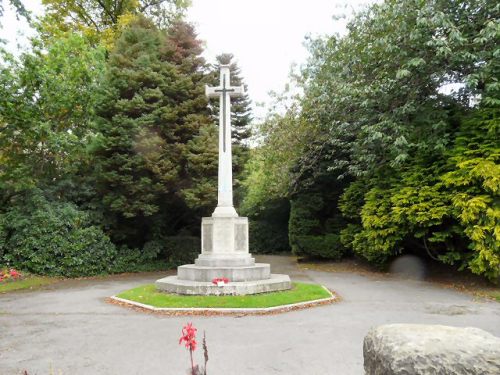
[0,34,104,203]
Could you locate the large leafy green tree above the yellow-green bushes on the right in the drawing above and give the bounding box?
[303,0,498,175]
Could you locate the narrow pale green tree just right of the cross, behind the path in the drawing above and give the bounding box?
[241,98,312,255]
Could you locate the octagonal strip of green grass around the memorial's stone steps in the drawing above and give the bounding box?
[117,283,331,308]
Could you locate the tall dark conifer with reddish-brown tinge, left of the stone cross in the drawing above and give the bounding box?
[96,17,210,246]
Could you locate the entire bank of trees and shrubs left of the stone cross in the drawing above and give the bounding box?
[0,0,250,276]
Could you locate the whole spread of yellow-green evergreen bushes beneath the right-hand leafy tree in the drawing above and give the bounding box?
[340,108,500,281]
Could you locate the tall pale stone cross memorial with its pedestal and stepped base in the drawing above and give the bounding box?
[156,65,291,295]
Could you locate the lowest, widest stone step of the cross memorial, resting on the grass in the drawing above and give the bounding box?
[155,274,292,296]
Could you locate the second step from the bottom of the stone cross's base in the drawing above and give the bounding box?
[177,263,271,282]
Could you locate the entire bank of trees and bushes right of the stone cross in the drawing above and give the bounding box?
[245,0,500,280]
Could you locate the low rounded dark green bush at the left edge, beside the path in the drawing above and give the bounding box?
[0,194,117,277]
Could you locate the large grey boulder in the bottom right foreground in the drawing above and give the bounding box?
[363,324,500,375]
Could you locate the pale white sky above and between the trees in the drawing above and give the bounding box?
[0,0,374,120]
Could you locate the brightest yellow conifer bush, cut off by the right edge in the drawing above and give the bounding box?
[441,108,500,281]
